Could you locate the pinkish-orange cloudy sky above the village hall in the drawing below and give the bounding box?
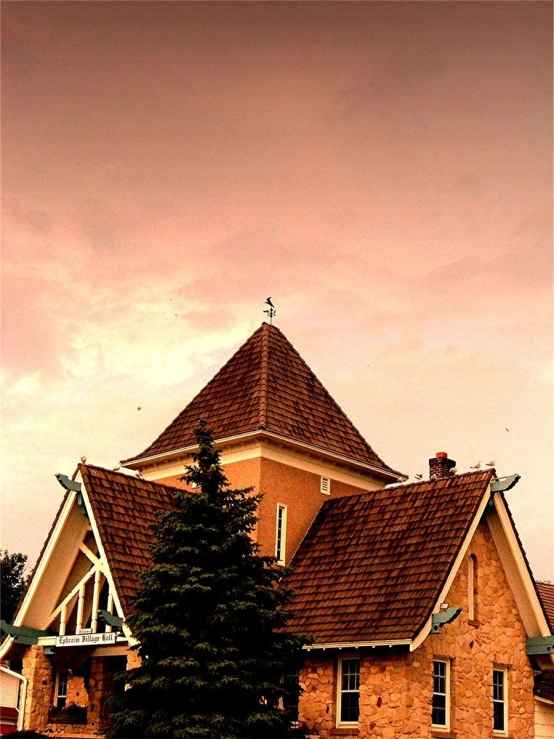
[0,0,554,579]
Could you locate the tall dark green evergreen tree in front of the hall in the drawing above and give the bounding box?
[107,423,305,739]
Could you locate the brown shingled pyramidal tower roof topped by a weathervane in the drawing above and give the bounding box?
[125,323,404,479]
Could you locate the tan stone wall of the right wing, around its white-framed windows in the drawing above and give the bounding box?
[300,524,534,739]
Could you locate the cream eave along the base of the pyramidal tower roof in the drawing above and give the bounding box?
[121,429,407,482]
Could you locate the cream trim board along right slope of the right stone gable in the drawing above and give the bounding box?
[487,493,550,637]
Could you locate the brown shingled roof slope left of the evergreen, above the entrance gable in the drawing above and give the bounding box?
[79,464,177,614]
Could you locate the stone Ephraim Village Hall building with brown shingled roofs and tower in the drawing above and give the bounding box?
[0,323,554,739]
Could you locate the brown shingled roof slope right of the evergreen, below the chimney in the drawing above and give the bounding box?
[287,470,494,644]
